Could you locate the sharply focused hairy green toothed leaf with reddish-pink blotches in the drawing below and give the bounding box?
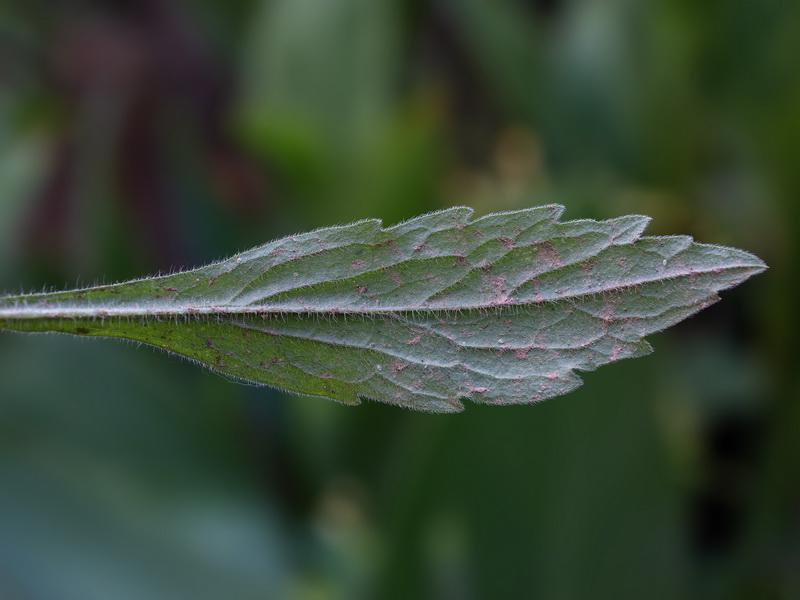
[0,205,766,412]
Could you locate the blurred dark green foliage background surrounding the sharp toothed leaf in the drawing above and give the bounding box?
[0,0,800,600]
